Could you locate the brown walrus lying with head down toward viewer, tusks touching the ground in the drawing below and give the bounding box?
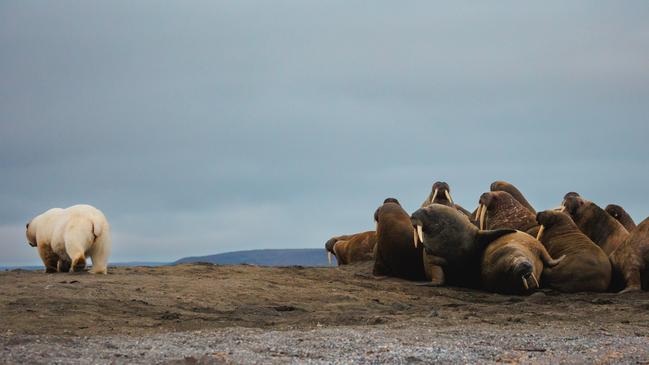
[481,231,563,294]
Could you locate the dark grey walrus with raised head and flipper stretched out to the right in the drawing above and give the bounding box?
[410,204,516,288]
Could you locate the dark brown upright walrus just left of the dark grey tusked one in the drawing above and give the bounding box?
[373,198,426,281]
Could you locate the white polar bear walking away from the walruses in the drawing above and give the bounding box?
[27,204,111,274]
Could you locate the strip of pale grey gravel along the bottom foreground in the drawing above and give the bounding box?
[0,320,649,364]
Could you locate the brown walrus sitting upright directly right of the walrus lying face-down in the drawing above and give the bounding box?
[536,210,611,293]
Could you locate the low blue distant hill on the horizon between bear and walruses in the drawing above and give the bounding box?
[172,248,335,266]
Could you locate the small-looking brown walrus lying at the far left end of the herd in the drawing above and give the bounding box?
[325,231,376,266]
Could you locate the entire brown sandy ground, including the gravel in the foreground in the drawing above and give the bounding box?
[0,264,649,364]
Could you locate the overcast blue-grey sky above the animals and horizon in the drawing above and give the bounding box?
[0,0,649,265]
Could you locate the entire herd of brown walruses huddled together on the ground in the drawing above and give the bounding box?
[325,181,649,294]
